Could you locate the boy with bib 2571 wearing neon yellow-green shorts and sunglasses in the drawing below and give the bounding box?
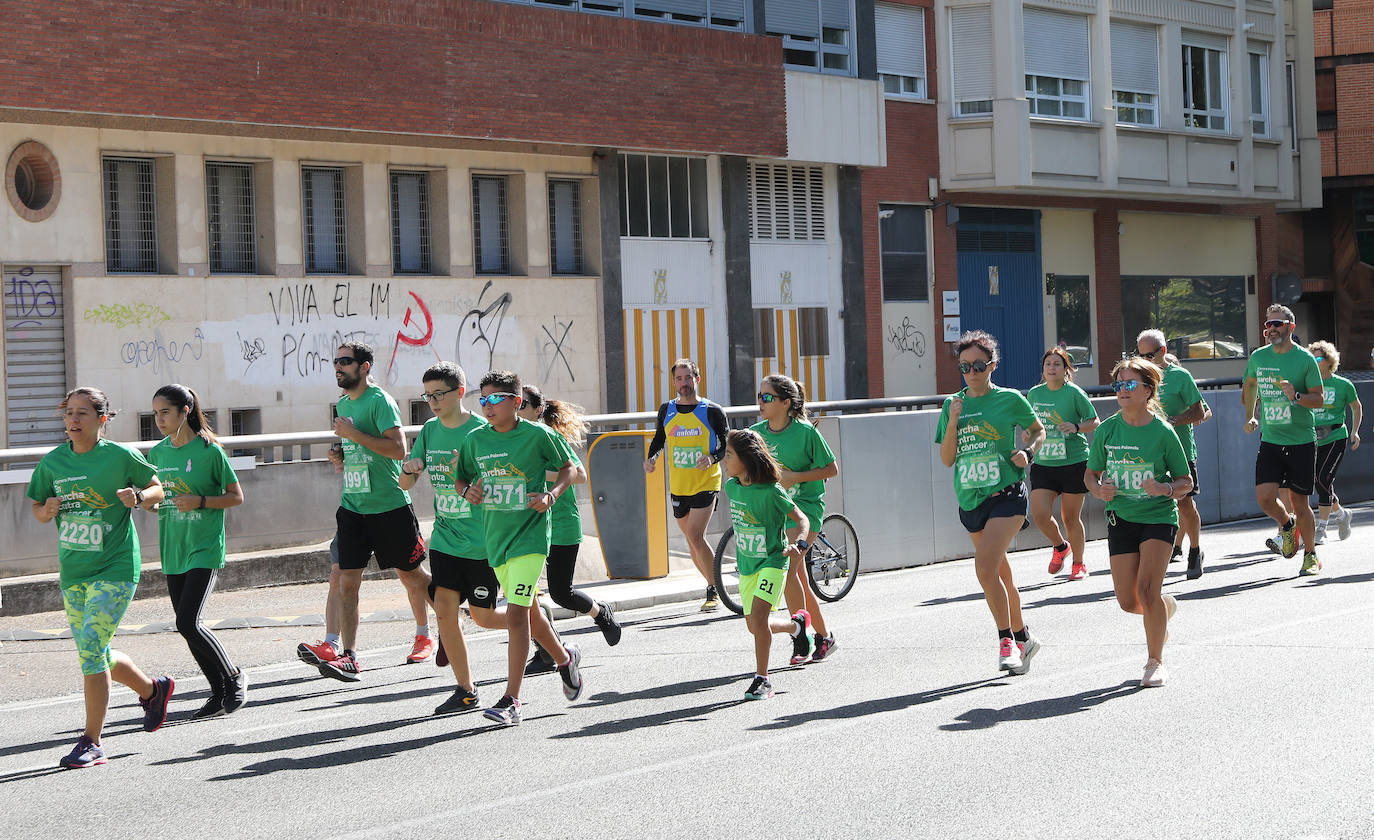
[453,370,584,726]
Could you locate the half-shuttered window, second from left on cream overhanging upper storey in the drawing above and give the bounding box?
[1024,8,1090,120]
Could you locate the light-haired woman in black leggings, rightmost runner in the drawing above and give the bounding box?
[1307,341,1364,546]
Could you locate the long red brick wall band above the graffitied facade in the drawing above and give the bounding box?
[0,0,786,155]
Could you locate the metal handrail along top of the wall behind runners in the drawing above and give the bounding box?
[0,377,1241,467]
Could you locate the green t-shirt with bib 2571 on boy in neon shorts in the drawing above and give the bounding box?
[456,418,573,568]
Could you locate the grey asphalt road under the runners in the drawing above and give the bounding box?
[0,511,1374,840]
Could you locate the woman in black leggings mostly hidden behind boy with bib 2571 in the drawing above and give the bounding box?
[519,385,621,651]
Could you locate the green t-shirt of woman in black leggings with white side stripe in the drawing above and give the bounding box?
[148,437,239,575]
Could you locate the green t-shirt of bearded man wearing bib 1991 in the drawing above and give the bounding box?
[338,385,411,513]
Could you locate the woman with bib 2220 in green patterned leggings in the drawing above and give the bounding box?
[27,388,176,769]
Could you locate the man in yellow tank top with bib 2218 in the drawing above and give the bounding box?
[644,359,730,612]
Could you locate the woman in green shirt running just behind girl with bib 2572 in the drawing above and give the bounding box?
[753,374,840,665]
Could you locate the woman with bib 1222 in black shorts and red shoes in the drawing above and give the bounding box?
[1028,346,1098,580]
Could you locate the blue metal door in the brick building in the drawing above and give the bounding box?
[958,208,1044,390]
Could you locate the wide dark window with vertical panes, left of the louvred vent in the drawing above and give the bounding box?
[620,154,710,239]
